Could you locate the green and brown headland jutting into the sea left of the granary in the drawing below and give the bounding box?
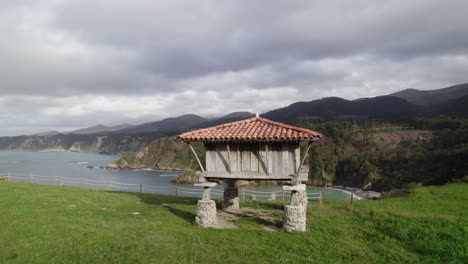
[111,138,205,170]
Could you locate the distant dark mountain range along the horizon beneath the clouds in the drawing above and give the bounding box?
[0,83,468,152]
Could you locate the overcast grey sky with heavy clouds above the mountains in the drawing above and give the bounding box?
[0,0,468,136]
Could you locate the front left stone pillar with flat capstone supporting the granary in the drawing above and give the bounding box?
[194,182,218,227]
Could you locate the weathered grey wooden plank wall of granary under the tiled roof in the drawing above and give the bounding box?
[205,143,300,175]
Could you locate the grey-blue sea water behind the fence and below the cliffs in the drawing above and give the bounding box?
[0,151,350,200]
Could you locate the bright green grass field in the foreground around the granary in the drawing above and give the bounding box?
[0,182,468,263]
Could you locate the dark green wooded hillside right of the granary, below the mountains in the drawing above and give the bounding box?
[302,118,468,191]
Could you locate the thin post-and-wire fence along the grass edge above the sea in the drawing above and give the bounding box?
[0,172,323,204]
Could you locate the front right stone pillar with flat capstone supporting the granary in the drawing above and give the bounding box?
[283,184,307,232]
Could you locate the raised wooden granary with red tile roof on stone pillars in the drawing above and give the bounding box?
[178,115,322,231]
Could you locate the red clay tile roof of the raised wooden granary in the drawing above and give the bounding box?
[178,117,322,142]
